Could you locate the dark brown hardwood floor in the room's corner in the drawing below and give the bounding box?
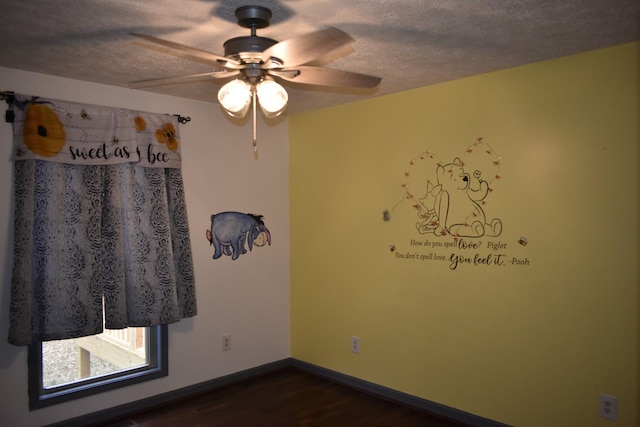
[103,367,468,427]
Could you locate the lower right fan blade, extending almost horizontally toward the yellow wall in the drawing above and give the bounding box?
[268,66,382,89]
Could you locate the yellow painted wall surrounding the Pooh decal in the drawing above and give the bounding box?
[289,43,640,427]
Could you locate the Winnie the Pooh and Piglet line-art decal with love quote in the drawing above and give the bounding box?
[383,138,529,270]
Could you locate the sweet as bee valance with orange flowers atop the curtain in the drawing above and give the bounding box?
[13,94,181,168]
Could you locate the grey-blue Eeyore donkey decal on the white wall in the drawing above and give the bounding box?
[207,212,271,260]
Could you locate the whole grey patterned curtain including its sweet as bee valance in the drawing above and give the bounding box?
[9,95,197,345]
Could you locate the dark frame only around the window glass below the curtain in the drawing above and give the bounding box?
[28,325,169,411]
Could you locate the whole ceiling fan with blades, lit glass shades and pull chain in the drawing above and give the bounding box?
[129,6,382,147]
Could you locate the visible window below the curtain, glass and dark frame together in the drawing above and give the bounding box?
[29,325,169,410]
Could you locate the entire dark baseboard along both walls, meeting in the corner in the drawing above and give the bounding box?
[47,358,509,427]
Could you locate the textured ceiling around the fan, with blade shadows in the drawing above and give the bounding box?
[0,0,640,114]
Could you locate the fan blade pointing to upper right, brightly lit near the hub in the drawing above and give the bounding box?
[262,27,355,68]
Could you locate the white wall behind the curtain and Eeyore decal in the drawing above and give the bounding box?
[0,68,290,427]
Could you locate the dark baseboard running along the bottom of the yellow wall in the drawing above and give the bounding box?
[289,359,510,427]
